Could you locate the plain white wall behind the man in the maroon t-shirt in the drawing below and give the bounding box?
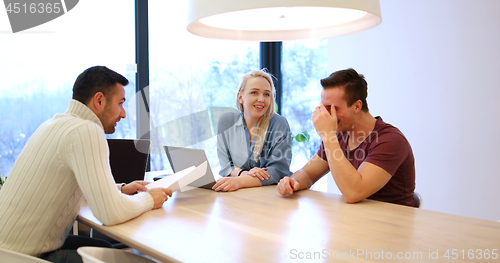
[328,0,500,220]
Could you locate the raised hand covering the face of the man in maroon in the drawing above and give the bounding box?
[311,103,337,141]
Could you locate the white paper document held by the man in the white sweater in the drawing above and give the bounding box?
[146,161,208,192]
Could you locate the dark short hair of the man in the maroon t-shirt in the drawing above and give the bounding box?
[321,68,368,111]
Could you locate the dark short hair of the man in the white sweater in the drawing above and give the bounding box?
[73,66,128,104]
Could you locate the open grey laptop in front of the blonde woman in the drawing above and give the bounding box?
[163,146,215,190]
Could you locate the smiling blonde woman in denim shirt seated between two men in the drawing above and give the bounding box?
[212,70,292,192]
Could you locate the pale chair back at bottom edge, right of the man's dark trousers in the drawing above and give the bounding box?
[76,247,155,263]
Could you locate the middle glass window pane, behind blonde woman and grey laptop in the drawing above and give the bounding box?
[149,0,259,174]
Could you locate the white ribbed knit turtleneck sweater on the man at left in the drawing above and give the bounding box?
[0,100,154,256]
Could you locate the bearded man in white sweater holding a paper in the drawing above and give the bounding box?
[0,66,172,262]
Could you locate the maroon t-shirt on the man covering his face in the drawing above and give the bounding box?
[317,117,415,206]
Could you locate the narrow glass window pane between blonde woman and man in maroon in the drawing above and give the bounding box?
[281,39,327,191]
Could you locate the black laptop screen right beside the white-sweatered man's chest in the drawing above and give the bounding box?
[108,139,151,184]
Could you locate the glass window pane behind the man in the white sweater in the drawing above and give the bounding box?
[0,0,135,175]
